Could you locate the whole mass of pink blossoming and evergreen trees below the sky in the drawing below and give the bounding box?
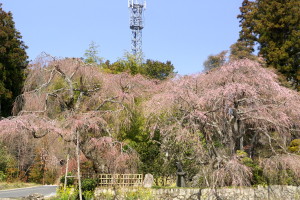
[0,0,300,190]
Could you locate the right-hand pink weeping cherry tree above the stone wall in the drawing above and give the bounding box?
[145,60,300,187]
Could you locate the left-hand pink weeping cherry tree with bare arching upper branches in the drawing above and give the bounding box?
[0,55,159,177]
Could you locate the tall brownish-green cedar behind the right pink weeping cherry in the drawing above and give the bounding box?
[238,0,300,90]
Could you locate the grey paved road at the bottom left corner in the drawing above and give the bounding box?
[0,185,57,198]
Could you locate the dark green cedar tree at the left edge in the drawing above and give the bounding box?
[0,3,28,117]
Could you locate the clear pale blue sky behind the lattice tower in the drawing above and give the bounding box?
[0,0,242,75]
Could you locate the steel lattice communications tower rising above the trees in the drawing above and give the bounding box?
[128,0,146,57]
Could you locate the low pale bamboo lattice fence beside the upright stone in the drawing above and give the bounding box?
[85,174,143,187]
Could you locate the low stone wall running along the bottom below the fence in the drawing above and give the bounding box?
[95,185,300,200]
